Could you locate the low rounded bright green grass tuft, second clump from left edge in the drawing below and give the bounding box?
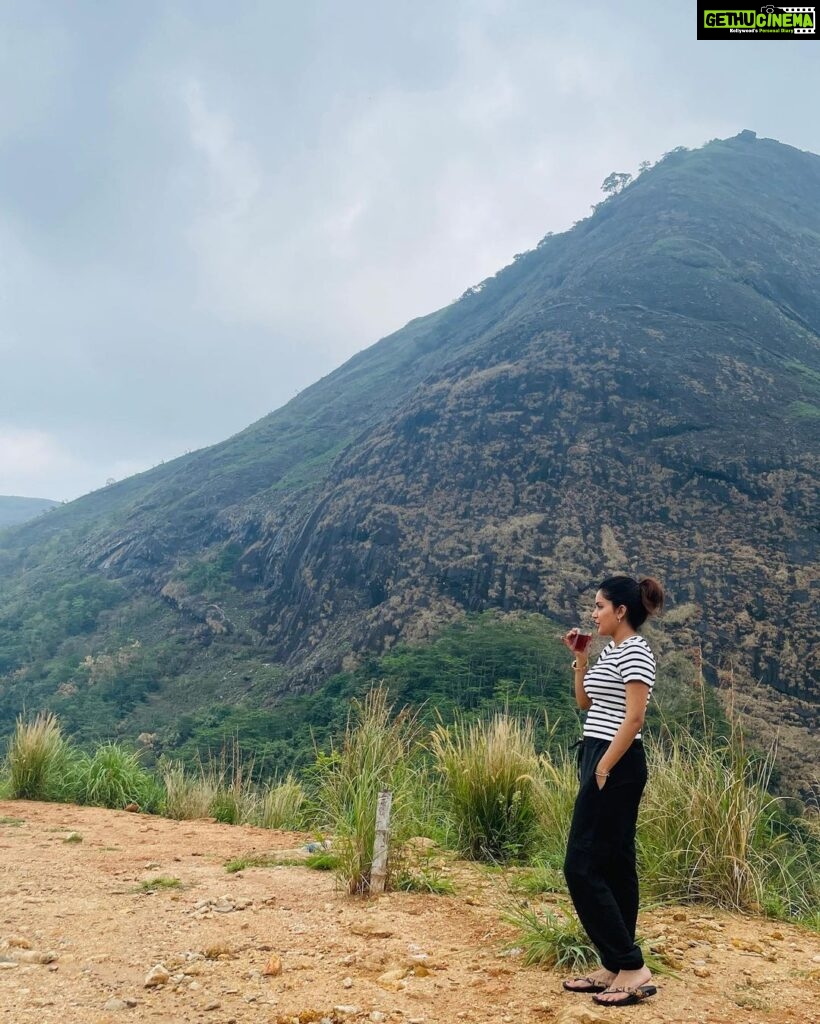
[70,743,160,810]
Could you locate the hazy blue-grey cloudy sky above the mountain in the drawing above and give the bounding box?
[0,0,820,501]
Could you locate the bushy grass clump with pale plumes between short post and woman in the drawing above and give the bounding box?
[431,713,542,861]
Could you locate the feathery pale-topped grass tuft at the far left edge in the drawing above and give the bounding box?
[6,712,73,800]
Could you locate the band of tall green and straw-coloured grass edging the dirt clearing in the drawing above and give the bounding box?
[0,687,820,937]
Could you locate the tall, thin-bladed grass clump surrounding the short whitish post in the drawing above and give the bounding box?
[315,687,418,894]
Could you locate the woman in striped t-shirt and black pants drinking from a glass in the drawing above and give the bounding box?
[564,575,663,1007]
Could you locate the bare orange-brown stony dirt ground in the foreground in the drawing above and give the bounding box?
[0,802,820,1024]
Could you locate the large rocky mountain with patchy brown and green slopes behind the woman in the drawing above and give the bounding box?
[0,132,820,792]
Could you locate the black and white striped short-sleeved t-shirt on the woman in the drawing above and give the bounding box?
[584,634,655,739]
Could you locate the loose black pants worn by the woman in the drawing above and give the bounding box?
[564,737,647,973]
